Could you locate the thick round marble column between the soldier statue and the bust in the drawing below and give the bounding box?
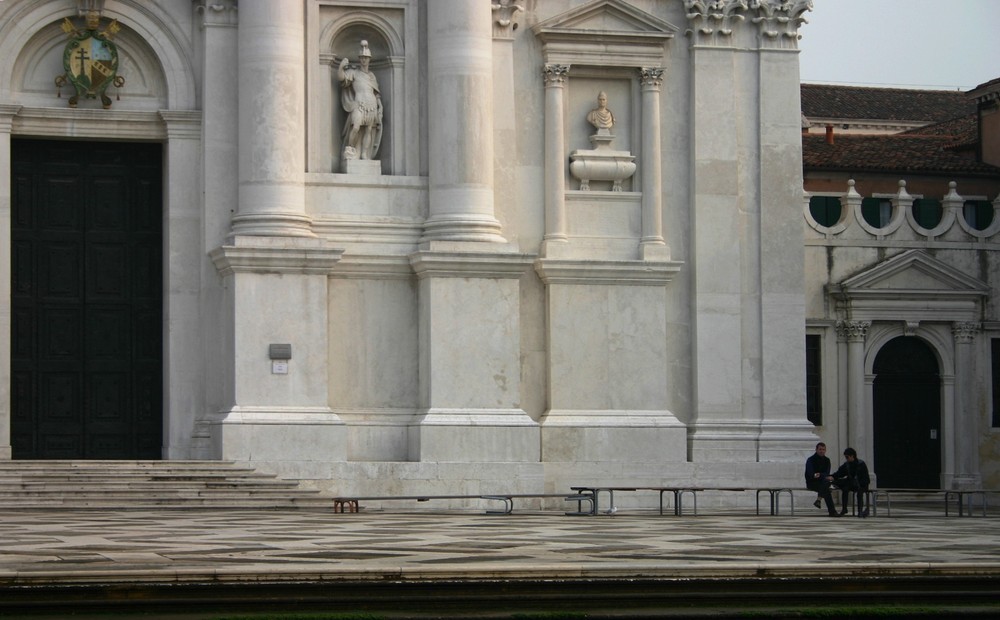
[421,0,506,243]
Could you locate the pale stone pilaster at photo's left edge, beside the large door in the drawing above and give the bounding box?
[0,105,21,460]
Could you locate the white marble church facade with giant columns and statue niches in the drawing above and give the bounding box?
[0,0,817,504]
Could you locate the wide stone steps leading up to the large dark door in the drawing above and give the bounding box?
[0,461,333,510]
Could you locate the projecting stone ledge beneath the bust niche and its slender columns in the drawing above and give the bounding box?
[535,258,683,286]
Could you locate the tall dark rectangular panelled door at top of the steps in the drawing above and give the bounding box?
[11,140,163,459]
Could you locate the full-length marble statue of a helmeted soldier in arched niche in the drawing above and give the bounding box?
[337,41,382,160]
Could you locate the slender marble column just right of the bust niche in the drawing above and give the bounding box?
[639,68,670,260]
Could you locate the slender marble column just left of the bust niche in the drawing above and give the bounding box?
[543,65,569,257]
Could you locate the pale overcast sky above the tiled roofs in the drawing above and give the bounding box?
[799,0,1000,90]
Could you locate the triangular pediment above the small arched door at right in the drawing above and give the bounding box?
[840,250,989,295]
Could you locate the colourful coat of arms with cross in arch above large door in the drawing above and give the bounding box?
[56,11,125,109]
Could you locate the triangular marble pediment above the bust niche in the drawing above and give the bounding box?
[532,0,678,67]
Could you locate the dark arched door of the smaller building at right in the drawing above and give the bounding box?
[872,336,941,489]
